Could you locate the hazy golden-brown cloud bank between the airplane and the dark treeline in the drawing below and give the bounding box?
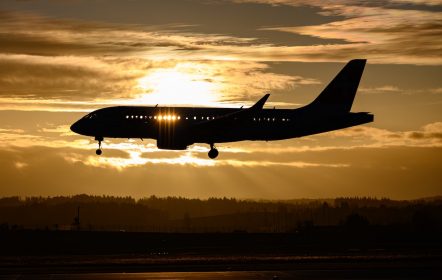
[0,146,441,199]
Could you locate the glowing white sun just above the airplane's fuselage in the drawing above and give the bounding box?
[133,67,219,106]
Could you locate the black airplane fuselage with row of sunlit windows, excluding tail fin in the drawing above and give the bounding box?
[72,106,373,149]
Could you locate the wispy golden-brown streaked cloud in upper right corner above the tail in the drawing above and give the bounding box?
[237,0,442,65]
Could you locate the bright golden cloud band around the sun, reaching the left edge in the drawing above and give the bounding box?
[0,55,310,108]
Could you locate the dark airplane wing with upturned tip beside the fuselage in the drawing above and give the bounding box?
[195,93,270,128]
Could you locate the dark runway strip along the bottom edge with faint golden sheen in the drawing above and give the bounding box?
[0,258,442,280]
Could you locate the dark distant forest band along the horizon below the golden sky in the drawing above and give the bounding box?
[0,195,442,232]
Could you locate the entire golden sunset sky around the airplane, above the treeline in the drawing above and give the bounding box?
[0,0,442,199]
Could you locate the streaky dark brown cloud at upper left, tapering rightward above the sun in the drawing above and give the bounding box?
[0,11,184,56]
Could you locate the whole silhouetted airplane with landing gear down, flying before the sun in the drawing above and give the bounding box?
[71,59,374,159]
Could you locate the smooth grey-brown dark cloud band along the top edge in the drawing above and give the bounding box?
[0,0,346,45]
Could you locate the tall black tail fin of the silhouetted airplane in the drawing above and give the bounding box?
[308,59,367,113]
